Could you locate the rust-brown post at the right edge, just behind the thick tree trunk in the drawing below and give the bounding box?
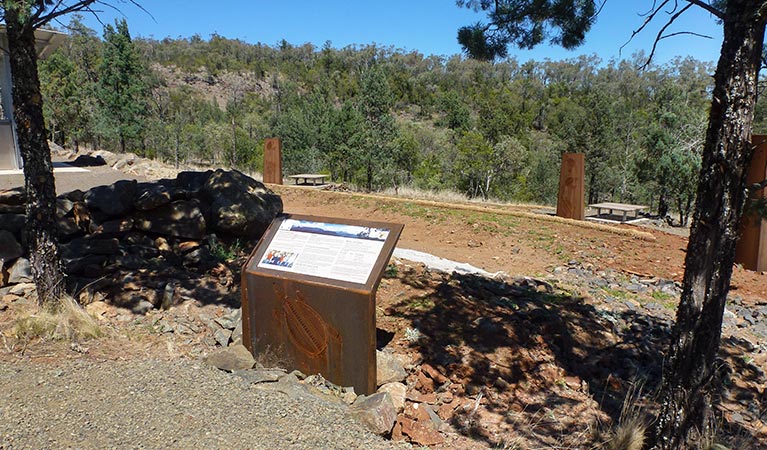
[735,134,767,271]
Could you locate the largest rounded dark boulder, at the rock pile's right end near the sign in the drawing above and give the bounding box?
[202,169,282,238]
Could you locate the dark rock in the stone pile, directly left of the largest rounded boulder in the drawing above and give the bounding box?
[133,200,205,239]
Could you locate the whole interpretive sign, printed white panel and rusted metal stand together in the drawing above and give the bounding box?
[242,214,403,394]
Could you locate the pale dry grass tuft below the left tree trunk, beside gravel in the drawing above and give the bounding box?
[13,296,104,342]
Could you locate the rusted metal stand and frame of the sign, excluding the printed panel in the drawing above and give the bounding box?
[242,215,403,394]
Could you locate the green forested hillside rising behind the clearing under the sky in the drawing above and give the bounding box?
[41,19,752,224]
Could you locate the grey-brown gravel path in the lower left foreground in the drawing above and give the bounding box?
[0,360,402,449]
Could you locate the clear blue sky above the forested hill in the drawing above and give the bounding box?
[78,0,722,63]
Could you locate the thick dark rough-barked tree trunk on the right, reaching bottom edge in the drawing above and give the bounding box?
[653,0,767,450]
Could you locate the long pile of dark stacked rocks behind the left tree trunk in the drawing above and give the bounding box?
[0,169,282,311]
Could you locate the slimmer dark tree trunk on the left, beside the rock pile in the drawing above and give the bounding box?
[5,7,64,307]
